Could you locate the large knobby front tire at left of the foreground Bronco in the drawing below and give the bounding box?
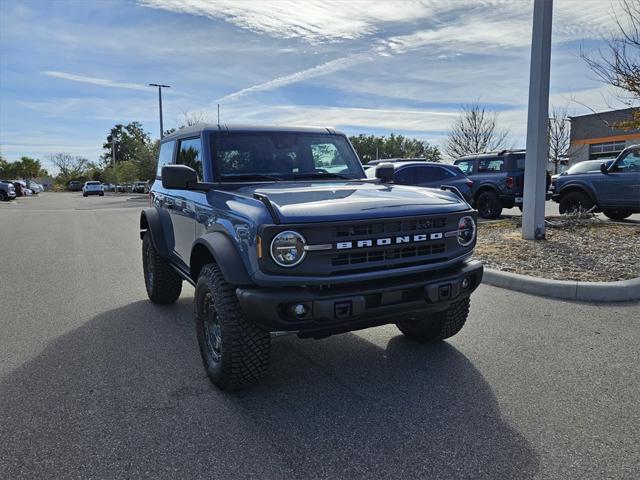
[194,263,271,391]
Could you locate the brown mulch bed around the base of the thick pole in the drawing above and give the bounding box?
[475,217,640,282]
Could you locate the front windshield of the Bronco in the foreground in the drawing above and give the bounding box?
[214,132,364,181]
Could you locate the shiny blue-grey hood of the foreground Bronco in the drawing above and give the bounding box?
[237,182,470,223]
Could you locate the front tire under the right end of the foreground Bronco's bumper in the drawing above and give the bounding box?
[396,297,471,343]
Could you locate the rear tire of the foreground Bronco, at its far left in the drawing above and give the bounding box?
[142,231,182,305]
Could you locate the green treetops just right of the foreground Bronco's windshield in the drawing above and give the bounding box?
[349,133,442,163]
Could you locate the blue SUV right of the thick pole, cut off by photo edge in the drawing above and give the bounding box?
[551,145,640,220]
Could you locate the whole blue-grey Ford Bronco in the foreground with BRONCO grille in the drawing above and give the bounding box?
[140,125,483,390]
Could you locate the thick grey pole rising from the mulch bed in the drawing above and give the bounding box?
[522,0,553,240]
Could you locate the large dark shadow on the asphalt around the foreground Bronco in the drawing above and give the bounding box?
[0,298,539,479]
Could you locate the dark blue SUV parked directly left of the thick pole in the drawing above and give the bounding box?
[454,150,551,218]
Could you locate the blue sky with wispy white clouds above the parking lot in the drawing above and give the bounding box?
[0,0,632,171]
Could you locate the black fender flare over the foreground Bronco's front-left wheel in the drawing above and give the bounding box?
[189,232,254,285]
